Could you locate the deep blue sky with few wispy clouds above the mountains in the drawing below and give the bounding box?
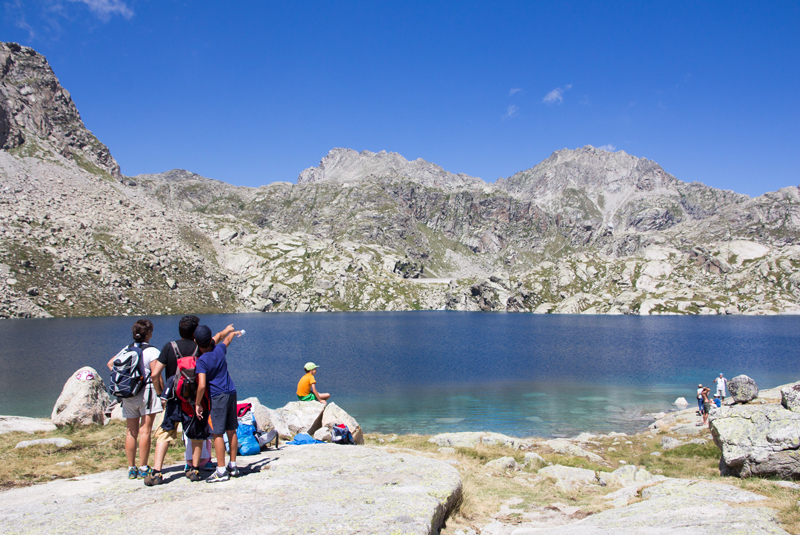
[0,0,800,195]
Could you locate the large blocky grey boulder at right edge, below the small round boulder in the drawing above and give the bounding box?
[710,405,800,479]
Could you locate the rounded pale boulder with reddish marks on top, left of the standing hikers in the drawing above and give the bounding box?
[50,366,111,427]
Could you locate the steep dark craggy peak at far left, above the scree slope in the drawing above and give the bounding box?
[0,42,122,178]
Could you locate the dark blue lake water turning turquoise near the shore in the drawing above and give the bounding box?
[0,312,800,436]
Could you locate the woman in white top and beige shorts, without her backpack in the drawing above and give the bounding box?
[108,319,162,479]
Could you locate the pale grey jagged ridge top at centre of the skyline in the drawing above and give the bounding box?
[297,148,486,188]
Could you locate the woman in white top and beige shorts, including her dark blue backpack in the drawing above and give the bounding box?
[108,319,162,479]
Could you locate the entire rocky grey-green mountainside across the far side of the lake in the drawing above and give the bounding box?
[0,44,800,317]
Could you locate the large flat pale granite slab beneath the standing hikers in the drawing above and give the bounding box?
[0,444,461,535]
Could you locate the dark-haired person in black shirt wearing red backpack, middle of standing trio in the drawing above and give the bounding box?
[144,316,213,487]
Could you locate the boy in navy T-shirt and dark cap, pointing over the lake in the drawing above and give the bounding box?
[194,325,242,483]
